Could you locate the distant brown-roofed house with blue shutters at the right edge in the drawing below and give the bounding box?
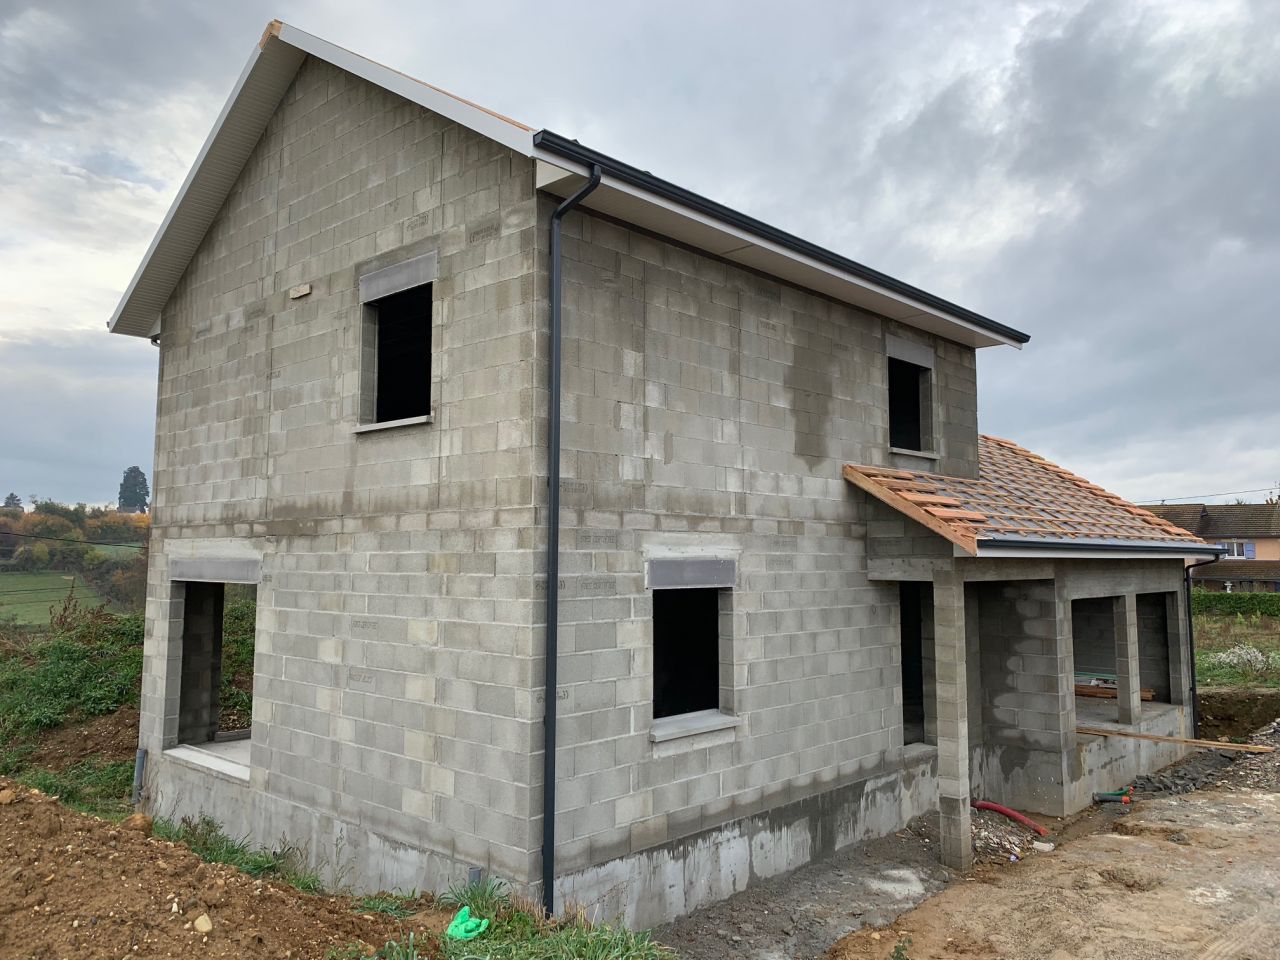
[1147,503,1280,593]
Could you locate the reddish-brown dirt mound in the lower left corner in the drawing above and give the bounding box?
[0,778,449,960]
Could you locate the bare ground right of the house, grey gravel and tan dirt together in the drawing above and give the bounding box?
[659,724,1280,960]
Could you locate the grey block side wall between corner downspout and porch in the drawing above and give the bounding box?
[538,205,977,899]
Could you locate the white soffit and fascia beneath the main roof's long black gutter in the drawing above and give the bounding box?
[534,150,1023,349]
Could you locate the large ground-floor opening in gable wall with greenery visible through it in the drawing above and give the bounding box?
[178,581,257,744]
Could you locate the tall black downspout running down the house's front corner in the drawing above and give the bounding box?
[543,165,600,916]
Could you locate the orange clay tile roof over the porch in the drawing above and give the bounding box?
[844,436,1220,556]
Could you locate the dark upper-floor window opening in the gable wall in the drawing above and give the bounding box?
[369,283,431,424]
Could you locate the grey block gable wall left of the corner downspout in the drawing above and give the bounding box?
[142,60,543,888]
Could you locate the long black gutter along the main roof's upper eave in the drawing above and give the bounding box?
[534,131,1030,343]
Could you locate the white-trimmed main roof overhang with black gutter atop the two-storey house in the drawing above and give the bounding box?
[108,20,1029,347]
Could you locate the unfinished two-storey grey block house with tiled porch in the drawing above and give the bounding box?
[110,23,1220,925]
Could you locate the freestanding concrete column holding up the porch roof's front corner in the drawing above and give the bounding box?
[933,570,973,870]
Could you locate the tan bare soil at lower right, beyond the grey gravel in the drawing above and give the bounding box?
[827,788,1280,960]
